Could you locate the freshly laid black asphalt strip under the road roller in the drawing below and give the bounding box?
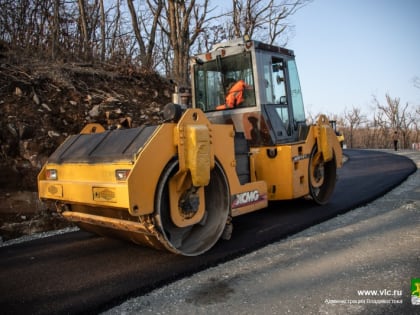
[0,150,416,314]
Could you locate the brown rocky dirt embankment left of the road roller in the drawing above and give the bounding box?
[0,45,172,240]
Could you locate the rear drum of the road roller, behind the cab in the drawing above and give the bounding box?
[309,145,337,205]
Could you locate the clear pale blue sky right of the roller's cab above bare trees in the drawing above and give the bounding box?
[213,0,420,116]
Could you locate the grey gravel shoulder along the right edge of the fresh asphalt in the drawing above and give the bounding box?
[104,151,420,315]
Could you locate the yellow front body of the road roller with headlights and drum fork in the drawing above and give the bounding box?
[38,109,268,255]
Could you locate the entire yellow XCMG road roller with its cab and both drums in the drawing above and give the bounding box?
[38,39,341,256]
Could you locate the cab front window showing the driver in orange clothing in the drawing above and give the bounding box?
[194,52,256,112]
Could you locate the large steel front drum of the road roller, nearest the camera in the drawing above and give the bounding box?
[155,160,230,256]
